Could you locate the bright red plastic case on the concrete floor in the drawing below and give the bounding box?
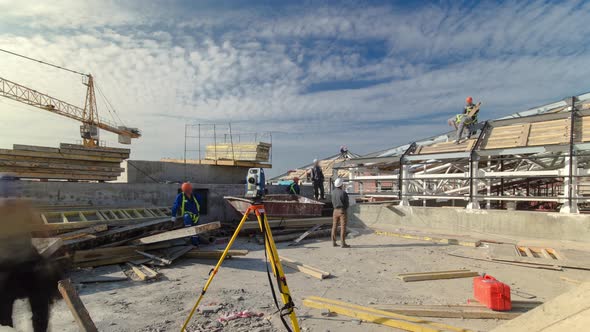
[473,275,512,311]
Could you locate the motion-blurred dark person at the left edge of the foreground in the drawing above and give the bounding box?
[0,175,63,332]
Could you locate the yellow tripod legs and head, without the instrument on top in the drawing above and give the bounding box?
[181,202,300,332]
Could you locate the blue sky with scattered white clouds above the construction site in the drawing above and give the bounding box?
[0,0,590,175]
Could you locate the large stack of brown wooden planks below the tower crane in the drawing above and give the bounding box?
[0,143,130,181]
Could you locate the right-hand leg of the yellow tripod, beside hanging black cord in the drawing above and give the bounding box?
[256,210,300,332]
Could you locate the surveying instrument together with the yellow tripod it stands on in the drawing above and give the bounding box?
[181,168,300,332]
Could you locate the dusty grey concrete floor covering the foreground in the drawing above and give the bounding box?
[8,234,590,332]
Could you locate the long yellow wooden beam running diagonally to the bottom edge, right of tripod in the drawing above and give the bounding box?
[303,296,470,332]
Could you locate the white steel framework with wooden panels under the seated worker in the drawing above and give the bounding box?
[335,94,590,213]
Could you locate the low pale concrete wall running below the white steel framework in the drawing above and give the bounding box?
[351,204,590,242]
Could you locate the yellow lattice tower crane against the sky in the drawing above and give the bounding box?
[0,50,141,147]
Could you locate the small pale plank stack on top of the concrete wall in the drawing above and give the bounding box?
[205,142,272,162]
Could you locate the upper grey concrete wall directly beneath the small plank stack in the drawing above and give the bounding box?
[116,160,248,184]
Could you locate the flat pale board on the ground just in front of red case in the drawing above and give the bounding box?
[372,301,542,319]
